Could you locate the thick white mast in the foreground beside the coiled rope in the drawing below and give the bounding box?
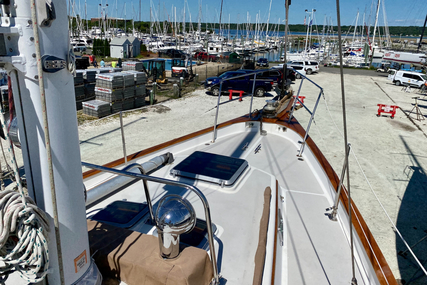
[2,0,99,285]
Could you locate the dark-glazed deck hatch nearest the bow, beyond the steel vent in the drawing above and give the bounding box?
[170,151,248,186]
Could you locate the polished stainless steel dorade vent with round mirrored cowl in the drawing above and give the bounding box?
[156,195,196,259]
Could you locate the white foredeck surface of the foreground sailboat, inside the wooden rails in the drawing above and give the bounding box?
[85,123,377,284]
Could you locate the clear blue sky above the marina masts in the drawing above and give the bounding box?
[74,0,427,26]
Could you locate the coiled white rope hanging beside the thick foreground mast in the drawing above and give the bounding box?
[0,190,49,283]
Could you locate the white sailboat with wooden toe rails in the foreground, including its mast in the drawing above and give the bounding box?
[0,0,397,285]
